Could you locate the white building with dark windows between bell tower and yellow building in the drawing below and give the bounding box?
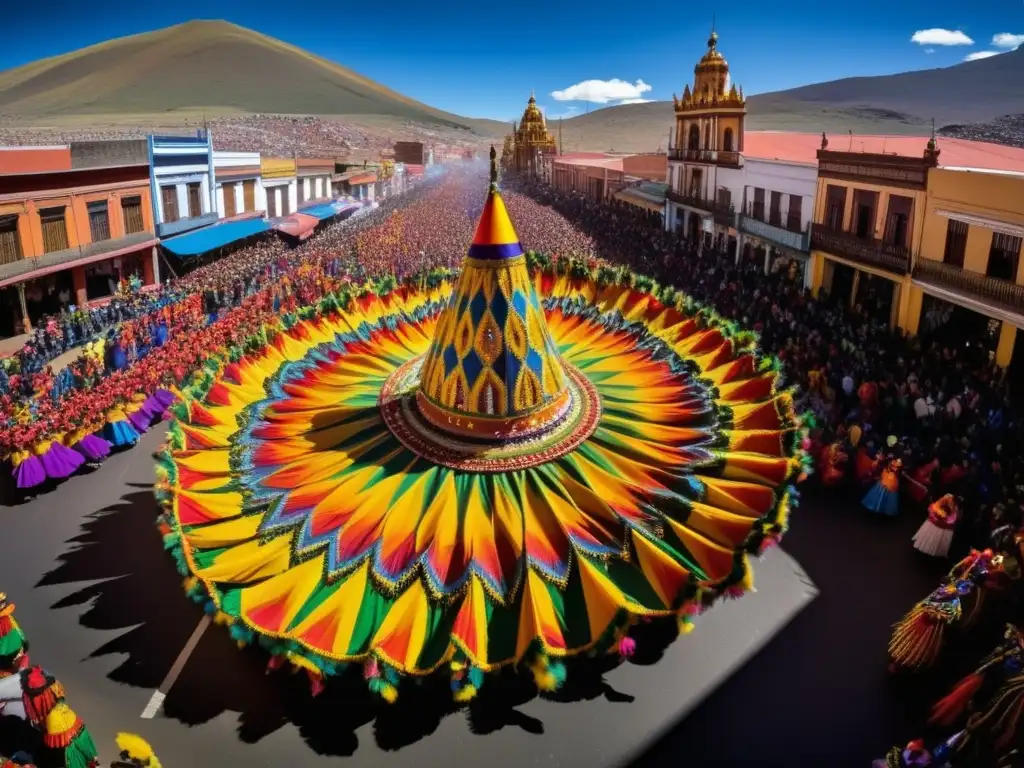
[736,157,818,288]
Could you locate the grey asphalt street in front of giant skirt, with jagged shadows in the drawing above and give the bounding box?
[0,429,817,768]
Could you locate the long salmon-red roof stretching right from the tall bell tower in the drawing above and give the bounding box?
[743,131,1024,173]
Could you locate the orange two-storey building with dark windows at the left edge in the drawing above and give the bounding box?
[0,142,159,336]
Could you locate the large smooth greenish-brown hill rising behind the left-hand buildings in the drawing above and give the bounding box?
[0,22,503,130]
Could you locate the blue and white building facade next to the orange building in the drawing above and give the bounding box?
[148,130,218,238]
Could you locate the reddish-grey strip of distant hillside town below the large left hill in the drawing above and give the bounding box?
[0,115,477,158]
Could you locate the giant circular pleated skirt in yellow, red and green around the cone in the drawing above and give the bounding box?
[158,274,801,696]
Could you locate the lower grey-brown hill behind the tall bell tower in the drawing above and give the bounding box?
[562,47,1024,152]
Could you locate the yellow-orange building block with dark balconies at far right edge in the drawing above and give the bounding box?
[810,136,1024,367]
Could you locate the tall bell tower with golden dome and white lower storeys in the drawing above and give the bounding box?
[666,32,746,248]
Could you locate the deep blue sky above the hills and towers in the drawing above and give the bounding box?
[0,0,1024,120]
